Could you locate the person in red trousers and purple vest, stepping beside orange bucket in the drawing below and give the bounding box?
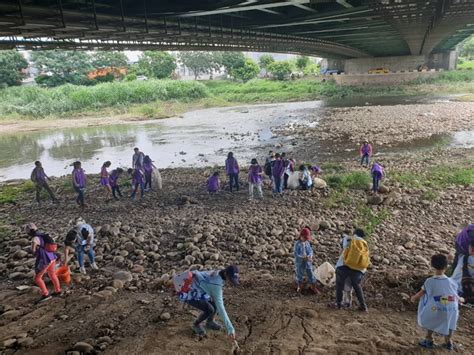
[25,223,61,302]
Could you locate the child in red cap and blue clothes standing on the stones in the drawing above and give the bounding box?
[294,227,319,294]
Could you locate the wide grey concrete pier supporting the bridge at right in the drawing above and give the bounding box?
[342,51,457,74]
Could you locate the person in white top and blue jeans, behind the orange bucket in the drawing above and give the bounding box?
[64,219,99,274]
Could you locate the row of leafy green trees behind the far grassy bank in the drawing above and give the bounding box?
[0,50,319,87]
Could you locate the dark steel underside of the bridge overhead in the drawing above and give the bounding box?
[0,0,474,58]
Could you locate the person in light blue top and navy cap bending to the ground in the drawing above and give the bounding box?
[184,265,239,340]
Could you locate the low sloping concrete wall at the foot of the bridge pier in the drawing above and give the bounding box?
[330,71,440,86]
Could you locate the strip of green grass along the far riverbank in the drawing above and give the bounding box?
[0,70,474,119]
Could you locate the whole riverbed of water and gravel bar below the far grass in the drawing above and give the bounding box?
[0,97,474,180]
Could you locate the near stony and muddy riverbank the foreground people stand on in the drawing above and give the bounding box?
[0,149,474,354]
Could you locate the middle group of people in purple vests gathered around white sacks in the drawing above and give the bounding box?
[207,151,321,200]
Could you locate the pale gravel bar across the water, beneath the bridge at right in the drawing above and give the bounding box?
[275,102,474,147]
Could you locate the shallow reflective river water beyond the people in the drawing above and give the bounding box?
[0,97,474,180]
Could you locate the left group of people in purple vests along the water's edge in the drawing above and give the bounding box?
[31,148,157,207]
